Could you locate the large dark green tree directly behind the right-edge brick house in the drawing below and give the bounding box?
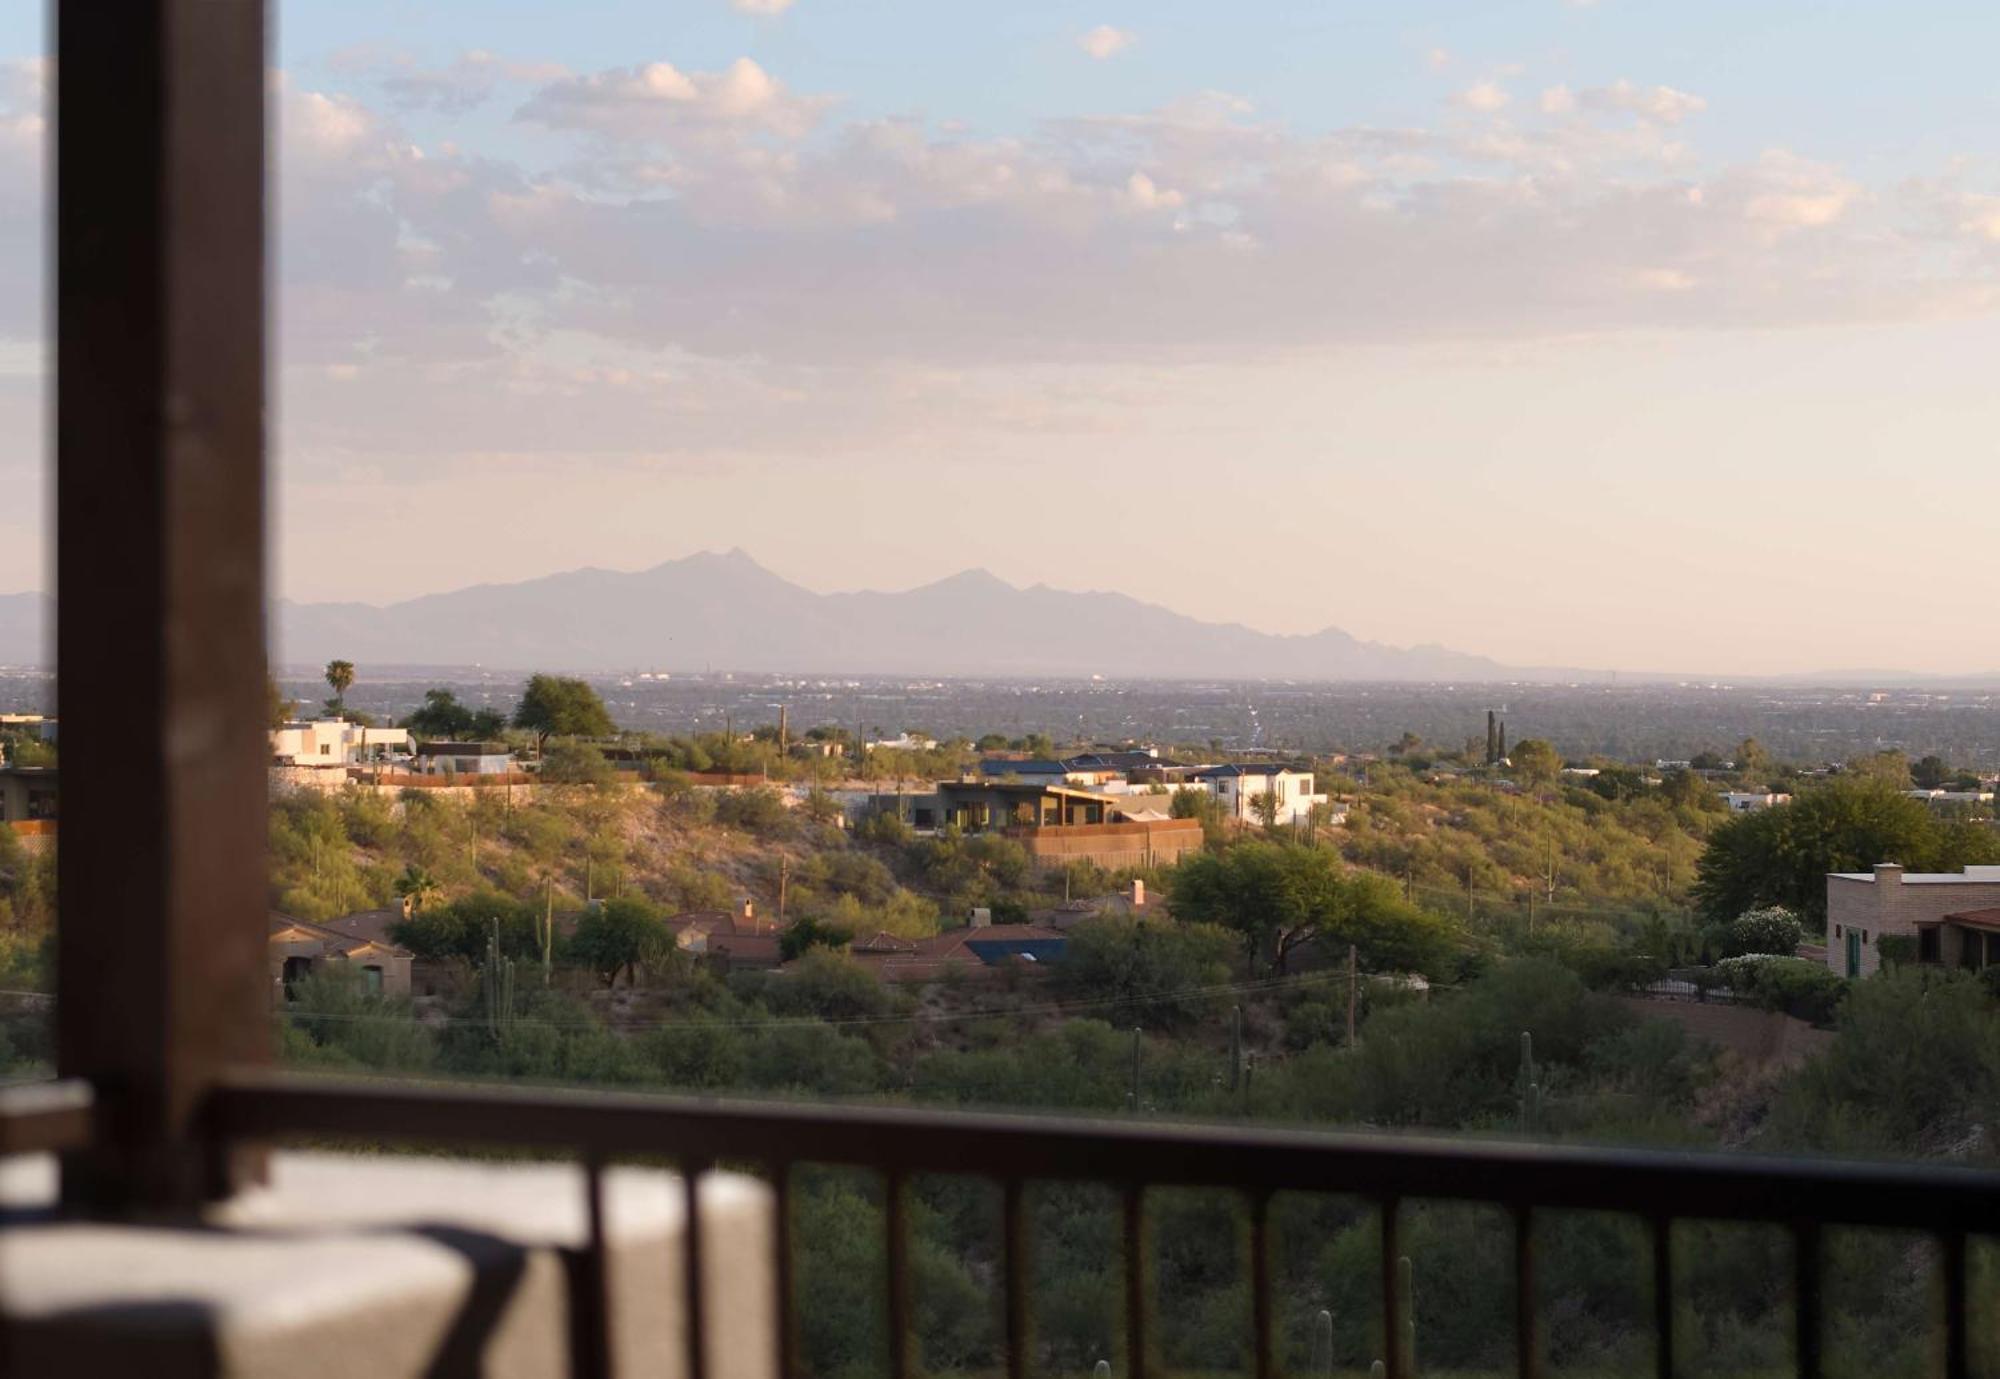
[1694,775,2000,929]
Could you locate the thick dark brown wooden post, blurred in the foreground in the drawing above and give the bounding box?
[54,0,272,1211]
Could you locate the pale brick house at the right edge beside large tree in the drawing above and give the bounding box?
[1826,861,2000,977]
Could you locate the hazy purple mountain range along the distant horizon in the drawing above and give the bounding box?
[0,550,2000,686]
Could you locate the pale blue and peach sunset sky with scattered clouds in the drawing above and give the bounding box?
[0,0,2000,674]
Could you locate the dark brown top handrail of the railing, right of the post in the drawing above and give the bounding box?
[199,1071,2000,1233]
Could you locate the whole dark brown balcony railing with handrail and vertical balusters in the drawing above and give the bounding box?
[15,1073,2000,1379]
